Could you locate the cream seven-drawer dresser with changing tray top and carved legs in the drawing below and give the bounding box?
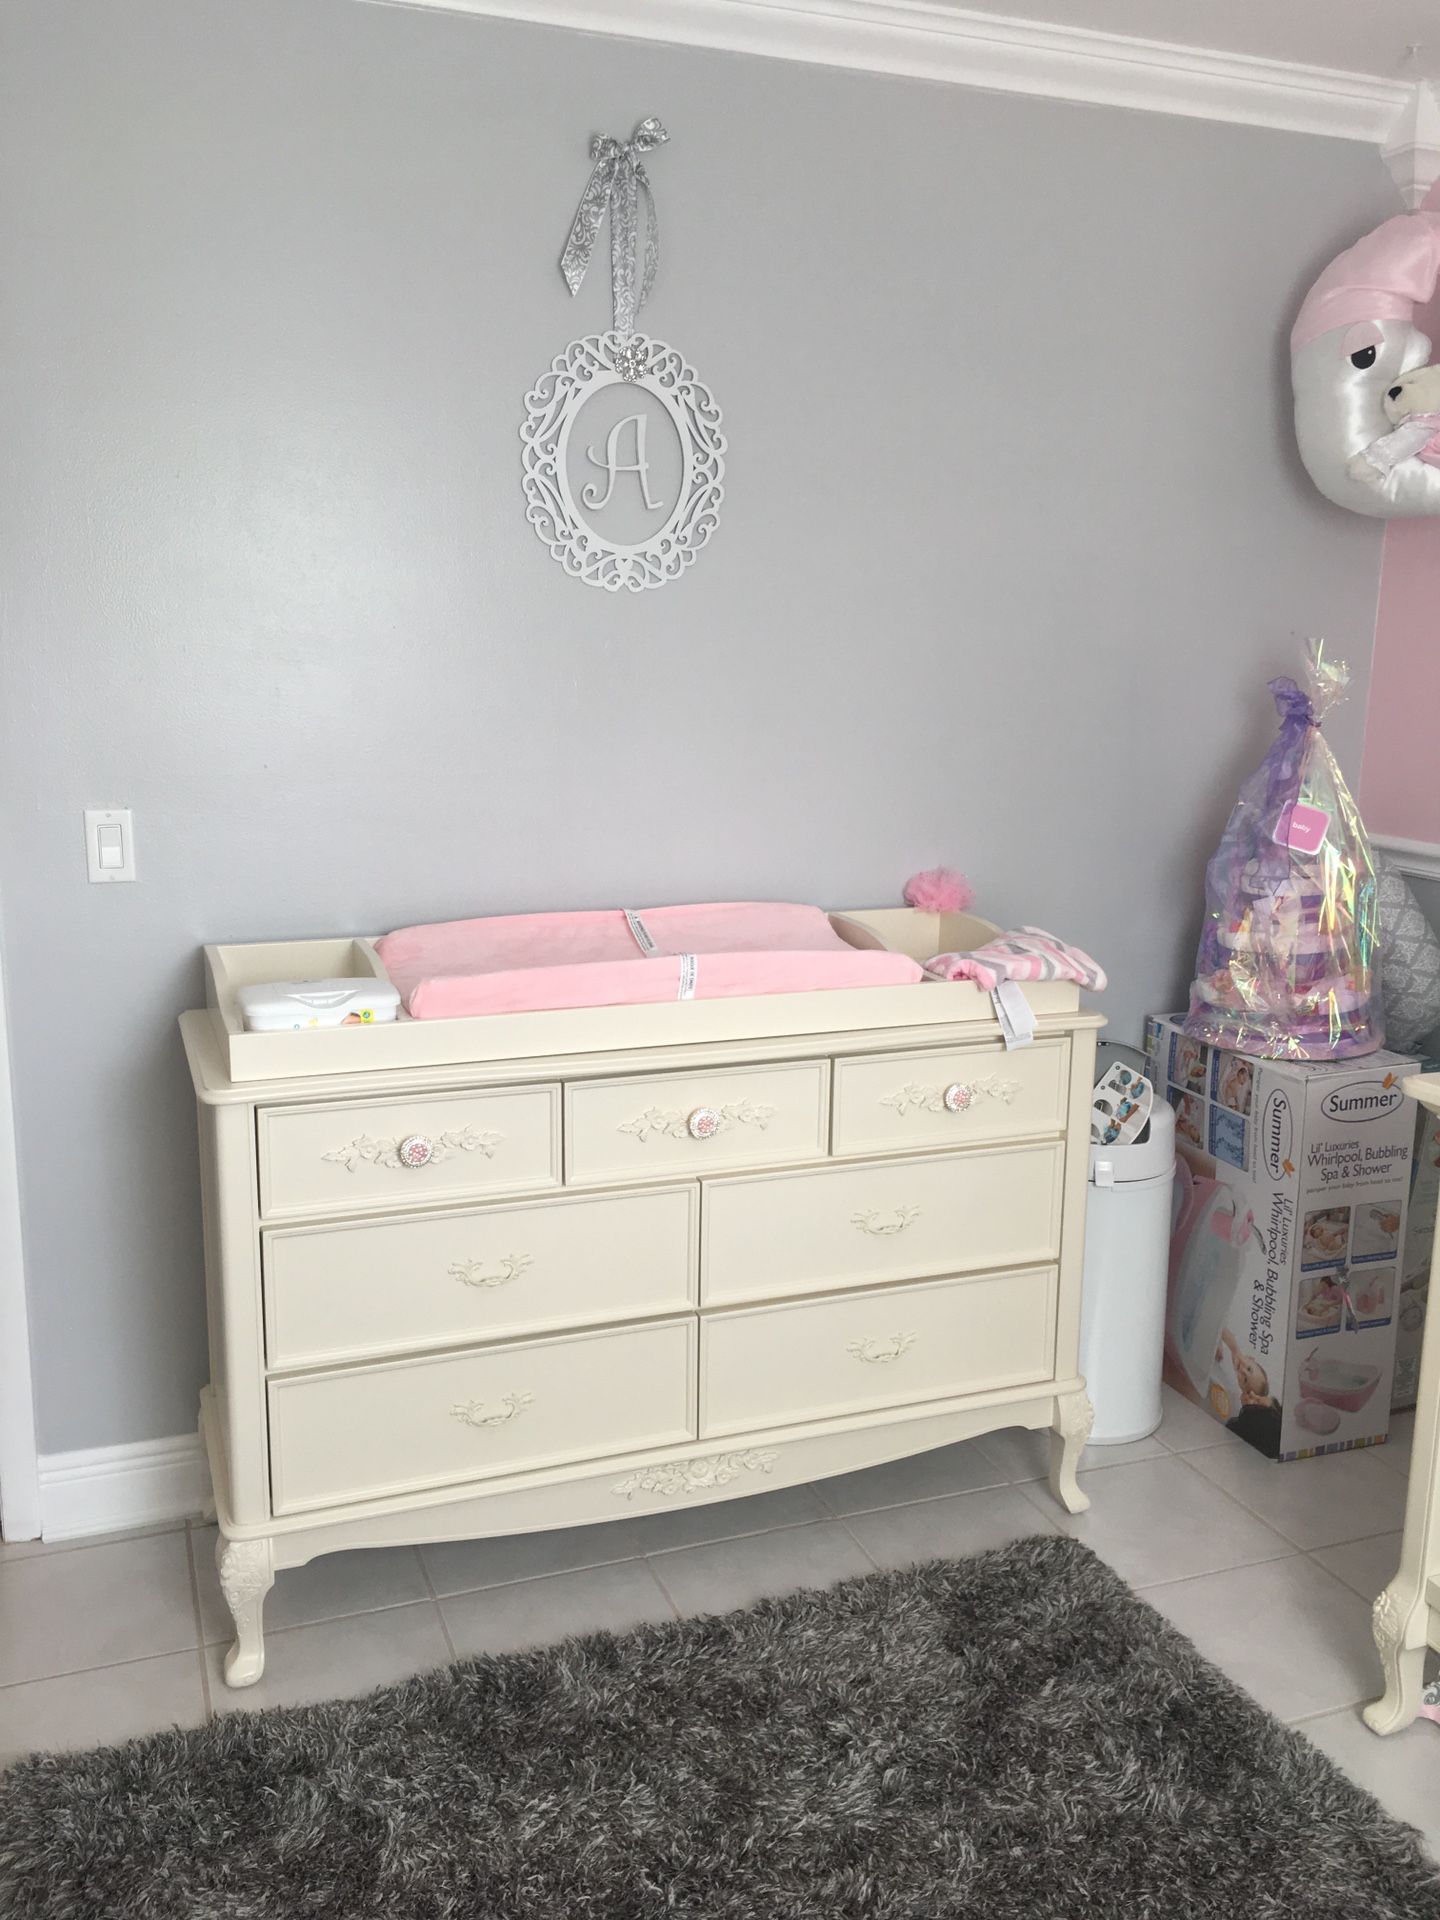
[180,910,1102,1686]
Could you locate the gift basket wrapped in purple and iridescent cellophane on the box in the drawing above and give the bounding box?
[1185,639,1384,1060]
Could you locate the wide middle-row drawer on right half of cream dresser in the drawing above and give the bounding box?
[701,1140,1066,1306]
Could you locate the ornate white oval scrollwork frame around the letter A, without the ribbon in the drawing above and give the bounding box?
[520,332,726,593]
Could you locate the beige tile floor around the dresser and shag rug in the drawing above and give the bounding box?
[0,1392,1440,1855]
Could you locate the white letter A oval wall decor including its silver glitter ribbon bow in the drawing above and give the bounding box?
[520,117,726,593]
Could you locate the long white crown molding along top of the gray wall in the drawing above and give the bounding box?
[367,0,1415,146]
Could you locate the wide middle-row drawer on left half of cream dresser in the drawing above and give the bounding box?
[263,1187,701,1367]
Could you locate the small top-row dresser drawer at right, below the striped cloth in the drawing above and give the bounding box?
[835,1041,1069,1154]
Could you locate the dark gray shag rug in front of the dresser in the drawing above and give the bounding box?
[0,1538,1440,1920]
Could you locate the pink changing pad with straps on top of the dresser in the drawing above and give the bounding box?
[374,900,924,1020]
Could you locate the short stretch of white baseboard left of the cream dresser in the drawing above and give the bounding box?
[40,1434,209,1540]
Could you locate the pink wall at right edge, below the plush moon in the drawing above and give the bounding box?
[1359,190,1440,845]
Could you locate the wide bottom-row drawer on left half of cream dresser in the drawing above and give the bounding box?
[269,1315,695,1513]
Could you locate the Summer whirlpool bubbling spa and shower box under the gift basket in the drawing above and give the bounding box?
[1146,1016,1415,1459]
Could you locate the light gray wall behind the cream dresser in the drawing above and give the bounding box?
[0,0,1394,1450]
